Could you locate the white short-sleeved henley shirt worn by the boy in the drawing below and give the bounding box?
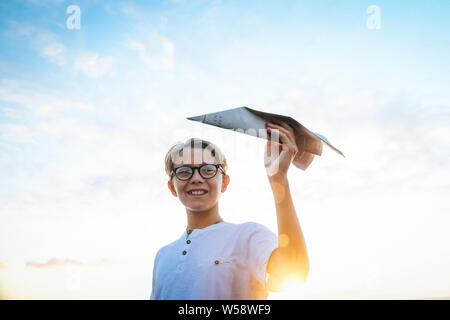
[150,222,278,300]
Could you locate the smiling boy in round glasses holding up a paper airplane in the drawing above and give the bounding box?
[150,122,309,300]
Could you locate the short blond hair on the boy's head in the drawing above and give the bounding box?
[165,138,228,177]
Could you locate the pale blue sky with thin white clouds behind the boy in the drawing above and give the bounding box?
[0,0,450,299]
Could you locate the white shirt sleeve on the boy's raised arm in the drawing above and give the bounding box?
[243,222,278,287]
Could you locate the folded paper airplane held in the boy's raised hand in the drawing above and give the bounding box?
[187,107,345,170]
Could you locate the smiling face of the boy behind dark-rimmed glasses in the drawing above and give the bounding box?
[168,148,230,211]
